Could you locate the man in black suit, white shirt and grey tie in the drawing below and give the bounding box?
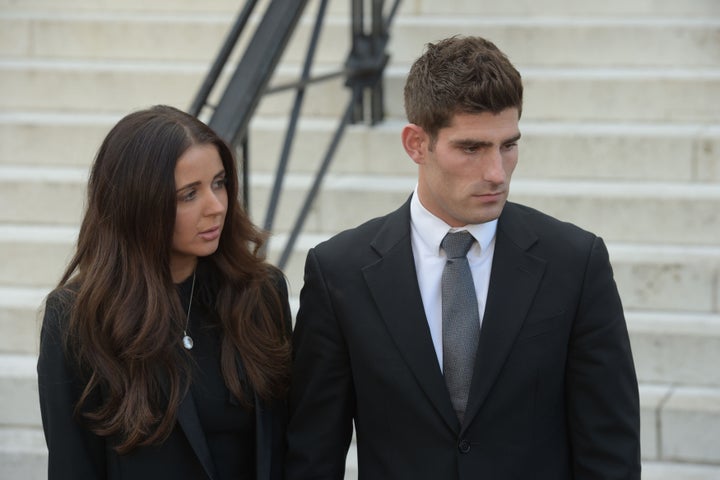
[286,37,640,480]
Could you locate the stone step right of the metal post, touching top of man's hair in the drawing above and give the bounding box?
[389,17,720,67]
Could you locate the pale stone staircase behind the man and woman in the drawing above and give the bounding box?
[0,0,720,480]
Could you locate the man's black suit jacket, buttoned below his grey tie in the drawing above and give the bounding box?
[286,197,640,480]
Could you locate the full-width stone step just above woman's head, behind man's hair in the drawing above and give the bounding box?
[0,58,720,123]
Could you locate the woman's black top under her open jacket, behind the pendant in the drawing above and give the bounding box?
[178,275,255,480]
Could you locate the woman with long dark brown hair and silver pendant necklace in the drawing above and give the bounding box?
[38,106,291,480]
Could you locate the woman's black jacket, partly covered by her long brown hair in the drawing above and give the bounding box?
[37,279,291,480]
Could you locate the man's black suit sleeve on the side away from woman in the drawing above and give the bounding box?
[566,238,640,480]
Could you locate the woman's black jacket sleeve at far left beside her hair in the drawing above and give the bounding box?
[37,294,106,480]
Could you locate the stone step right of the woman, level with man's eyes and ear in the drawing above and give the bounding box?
[252,118,720,182]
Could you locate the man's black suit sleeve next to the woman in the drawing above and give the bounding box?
[286,250,355,480]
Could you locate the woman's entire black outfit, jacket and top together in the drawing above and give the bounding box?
[37,261,291,480]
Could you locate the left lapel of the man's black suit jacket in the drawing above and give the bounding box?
[363,202,458,430]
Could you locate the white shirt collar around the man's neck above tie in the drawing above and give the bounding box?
[410,186,498,255]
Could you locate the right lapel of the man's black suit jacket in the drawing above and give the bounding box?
[464,204,545,426]
